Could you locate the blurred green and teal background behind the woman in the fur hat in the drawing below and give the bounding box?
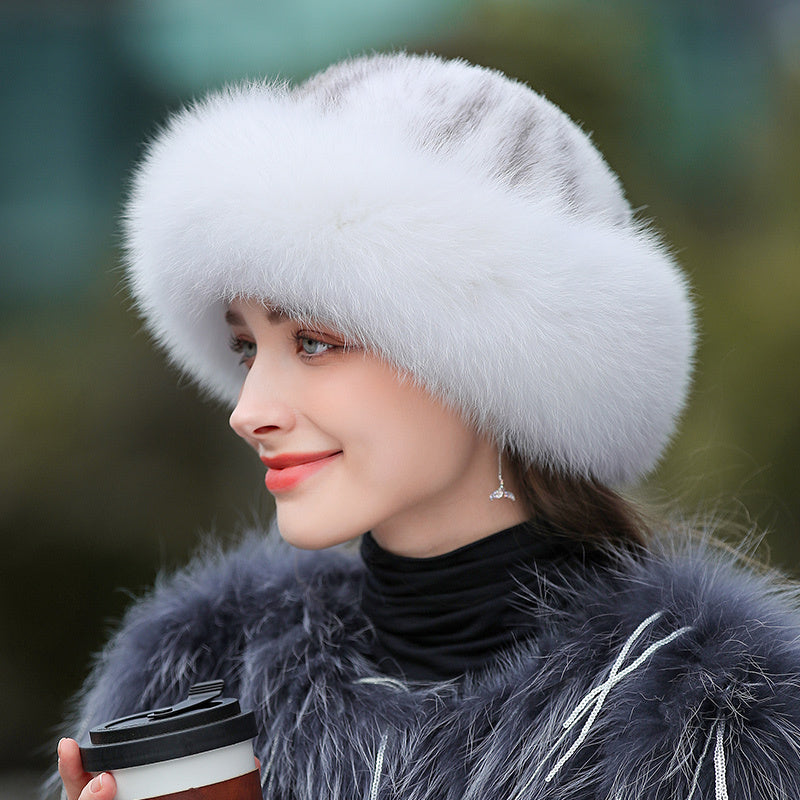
[0,0,800,800]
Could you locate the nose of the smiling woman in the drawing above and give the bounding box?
[229,365,295,448]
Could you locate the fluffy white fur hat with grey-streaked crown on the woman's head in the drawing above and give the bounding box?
[124,54,694,484]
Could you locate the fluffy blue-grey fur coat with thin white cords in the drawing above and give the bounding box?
[56,539,800,800]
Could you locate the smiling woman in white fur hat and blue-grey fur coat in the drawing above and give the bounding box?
[59,55,800,800]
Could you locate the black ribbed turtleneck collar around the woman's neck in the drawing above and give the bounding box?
[361,521,600,681]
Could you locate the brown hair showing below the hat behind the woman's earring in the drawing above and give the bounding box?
[509,454,650,550]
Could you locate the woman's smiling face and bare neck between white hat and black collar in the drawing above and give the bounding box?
[226,300,525,556]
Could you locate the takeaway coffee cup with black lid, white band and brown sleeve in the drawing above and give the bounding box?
[80,681,261,800]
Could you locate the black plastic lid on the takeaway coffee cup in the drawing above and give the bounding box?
[81,681,256,772]
